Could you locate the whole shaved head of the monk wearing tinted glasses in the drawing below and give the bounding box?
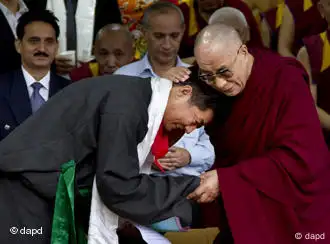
[194,24,254,96]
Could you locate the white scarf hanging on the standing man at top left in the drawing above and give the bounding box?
[47,0,96,62]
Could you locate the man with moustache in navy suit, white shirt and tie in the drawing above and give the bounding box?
[0,10,69,140]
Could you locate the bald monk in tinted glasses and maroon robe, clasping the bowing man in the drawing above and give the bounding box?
[173,25,330,244]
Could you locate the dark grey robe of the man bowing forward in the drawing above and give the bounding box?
[0,75,199,244]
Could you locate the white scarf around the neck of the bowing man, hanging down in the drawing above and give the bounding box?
[88,78,172,244]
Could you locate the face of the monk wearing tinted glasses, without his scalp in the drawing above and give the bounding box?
[195,45,249,96]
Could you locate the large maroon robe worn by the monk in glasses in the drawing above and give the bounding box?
[207,50,330,244]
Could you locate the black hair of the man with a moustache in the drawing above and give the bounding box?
[16,9,60,40]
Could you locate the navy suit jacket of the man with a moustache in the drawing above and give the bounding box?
[0,70,70,141]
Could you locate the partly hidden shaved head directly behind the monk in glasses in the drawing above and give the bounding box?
[209,7,250,43]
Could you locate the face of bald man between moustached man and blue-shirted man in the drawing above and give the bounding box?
[94,31,134,75]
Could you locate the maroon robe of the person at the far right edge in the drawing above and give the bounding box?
[304,31,330,148]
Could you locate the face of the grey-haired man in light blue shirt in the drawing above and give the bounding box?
[144,10,184,64]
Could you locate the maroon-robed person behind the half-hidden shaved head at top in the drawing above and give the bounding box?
[179,0,263,58]
